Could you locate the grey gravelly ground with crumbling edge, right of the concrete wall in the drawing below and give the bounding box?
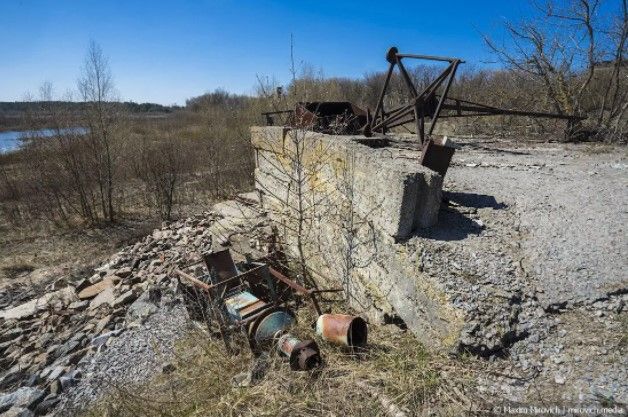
[442,140,628,406]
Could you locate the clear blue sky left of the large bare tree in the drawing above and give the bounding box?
[0,0,530,104]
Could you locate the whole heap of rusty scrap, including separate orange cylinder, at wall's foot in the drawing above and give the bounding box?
[176,249,367,370]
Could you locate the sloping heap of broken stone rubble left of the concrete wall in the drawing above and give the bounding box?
[0,196,270,415]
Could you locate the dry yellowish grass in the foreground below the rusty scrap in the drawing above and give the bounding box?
[81,308,478,417]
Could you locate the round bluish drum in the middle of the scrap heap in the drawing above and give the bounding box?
[247,307,296,354]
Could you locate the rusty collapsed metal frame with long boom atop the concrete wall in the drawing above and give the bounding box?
[262,46,583,175]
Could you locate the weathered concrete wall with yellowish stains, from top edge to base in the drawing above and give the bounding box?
[251,127,462,346]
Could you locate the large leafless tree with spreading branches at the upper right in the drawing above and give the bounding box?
[485,0,628,141]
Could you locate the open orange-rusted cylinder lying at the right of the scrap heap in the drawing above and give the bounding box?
[316,314,368,349]
